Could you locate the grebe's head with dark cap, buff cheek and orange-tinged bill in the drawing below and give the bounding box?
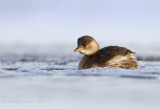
[74,35,99,55]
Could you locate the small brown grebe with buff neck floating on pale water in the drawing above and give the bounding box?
[75,36,138,69]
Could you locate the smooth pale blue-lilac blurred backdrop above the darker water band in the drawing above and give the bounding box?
[0,0,160,55]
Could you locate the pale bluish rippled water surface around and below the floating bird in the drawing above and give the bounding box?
[0,46,160,109]
